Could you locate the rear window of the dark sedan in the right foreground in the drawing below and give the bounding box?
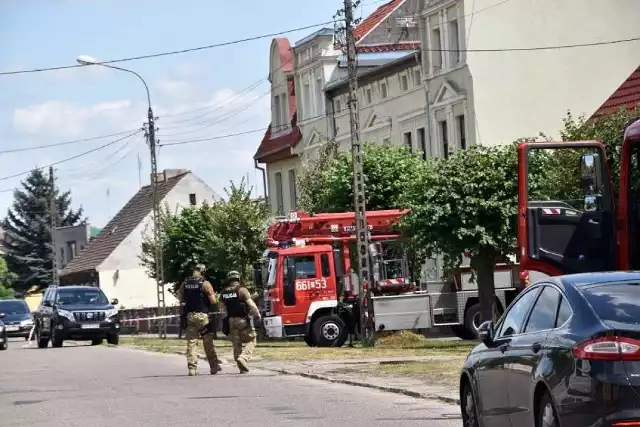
[582,283,640,324]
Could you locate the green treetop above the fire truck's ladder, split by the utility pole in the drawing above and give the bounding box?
[298,143,423,212]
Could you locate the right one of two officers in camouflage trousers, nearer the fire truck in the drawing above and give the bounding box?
[221,271,260,374]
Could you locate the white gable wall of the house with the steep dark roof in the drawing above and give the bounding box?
[97,173,220,308]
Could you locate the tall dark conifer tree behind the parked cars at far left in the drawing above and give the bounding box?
[2,169,86,292]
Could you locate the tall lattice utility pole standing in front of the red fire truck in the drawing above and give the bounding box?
[344,0,375,346]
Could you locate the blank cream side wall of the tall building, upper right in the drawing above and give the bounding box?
[464,0,640,145]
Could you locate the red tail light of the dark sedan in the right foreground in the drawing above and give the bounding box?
[573,336,640,362]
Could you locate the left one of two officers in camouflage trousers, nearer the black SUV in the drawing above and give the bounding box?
[178,264,221,376]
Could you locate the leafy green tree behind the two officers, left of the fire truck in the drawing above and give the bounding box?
[140,179,269,293]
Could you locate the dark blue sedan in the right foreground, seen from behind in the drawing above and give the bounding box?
[460,272,640,427]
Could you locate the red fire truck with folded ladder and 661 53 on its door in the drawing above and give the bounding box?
[254,210,521,347]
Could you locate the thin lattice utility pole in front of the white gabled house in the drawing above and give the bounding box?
[147,111,167,339]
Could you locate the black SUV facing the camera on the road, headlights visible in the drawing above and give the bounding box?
[35,286,120,348]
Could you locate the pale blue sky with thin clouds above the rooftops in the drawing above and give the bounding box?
[0,0,384,227]
